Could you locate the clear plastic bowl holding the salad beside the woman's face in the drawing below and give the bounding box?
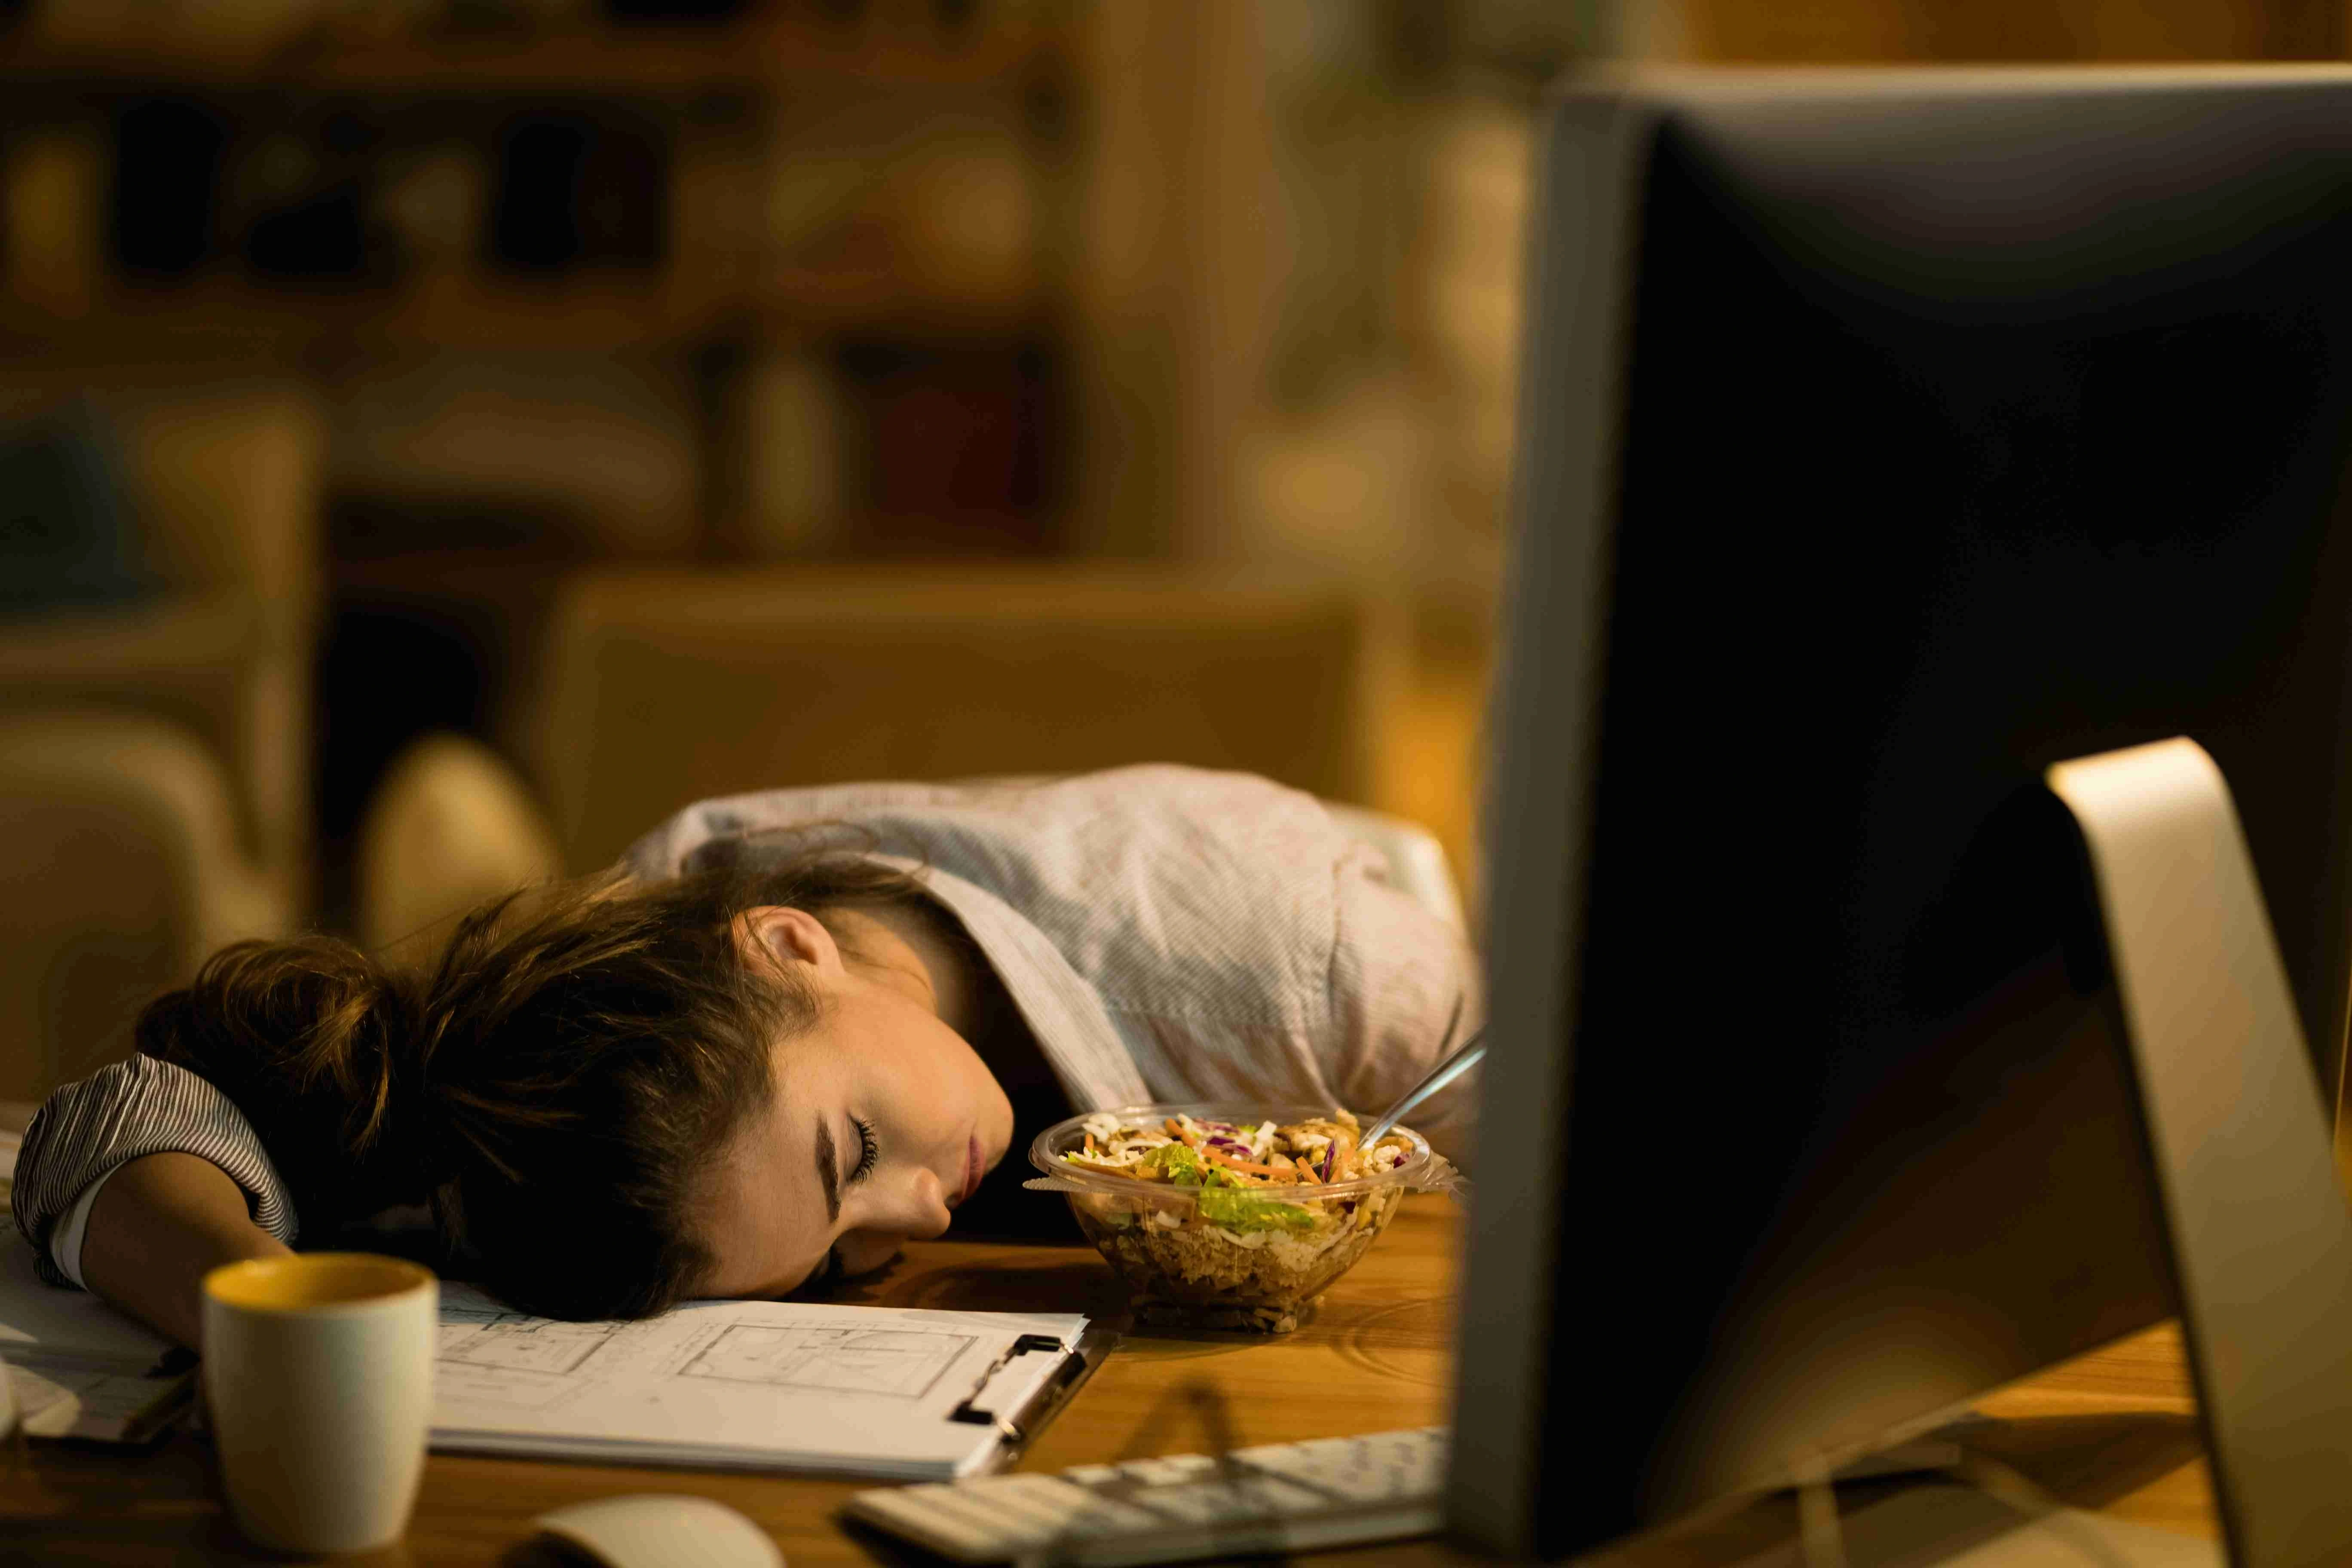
[1028,1105,1454,1333]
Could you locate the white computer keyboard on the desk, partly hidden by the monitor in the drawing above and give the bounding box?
[849,1427,1446,1568]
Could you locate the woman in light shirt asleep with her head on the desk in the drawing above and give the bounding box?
[14,766,1482,1344]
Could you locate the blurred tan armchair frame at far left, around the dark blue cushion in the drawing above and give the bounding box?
[0,379,325,900]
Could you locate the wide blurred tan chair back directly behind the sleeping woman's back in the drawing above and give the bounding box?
[513,567,1404,872]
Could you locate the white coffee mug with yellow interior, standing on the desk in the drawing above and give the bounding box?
[205,1253,440,1552]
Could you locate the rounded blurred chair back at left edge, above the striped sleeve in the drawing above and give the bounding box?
[0,710,292,1100]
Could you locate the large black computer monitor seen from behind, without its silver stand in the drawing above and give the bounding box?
[1449,68,2352,1556]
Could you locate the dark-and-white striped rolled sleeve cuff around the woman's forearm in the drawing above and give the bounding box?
[9,1056,296,1286]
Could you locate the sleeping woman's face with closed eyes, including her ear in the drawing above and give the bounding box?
[703,907,1014,1298]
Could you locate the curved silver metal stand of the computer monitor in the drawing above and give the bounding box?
[1839,738,2352,1568]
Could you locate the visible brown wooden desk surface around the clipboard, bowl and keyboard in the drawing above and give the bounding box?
[0,1199,2211,1568]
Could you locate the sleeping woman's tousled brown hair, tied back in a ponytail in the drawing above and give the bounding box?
[136,851,920,1319]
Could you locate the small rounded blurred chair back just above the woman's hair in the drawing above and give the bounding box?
[358,736,562,962]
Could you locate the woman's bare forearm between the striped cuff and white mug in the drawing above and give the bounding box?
[83,1152,292,1349]
